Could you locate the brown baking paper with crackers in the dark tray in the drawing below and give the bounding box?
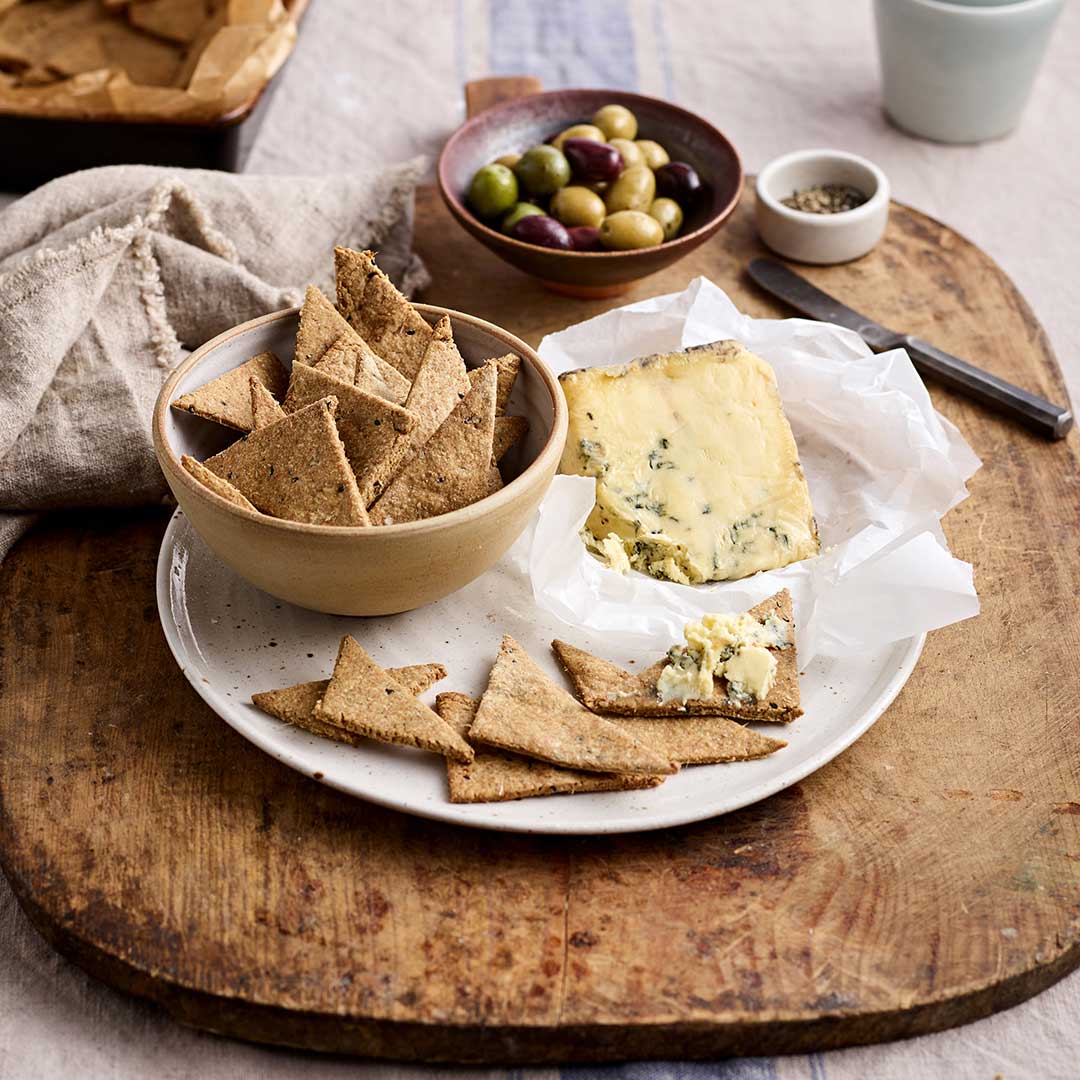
[0,0,296,122]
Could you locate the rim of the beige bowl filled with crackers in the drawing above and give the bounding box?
[152,303,568,540]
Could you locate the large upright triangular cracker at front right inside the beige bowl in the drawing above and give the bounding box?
[370,363,502,525]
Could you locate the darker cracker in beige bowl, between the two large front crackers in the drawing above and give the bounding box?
[285,364,417,507]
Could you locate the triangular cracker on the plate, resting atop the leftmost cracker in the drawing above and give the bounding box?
[313,634,473,761]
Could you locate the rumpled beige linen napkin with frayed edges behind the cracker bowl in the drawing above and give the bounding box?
[0,159,427,559]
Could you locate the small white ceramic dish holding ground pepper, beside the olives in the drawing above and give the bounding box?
[756,150,889,266]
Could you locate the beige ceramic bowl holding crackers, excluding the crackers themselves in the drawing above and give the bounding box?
[153,303,566,615]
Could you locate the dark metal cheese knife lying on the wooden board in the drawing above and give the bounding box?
[748,258,1072,438]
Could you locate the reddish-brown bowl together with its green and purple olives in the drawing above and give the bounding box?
[438,90,743,297]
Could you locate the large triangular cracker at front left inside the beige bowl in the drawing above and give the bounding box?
[203,396,369,525]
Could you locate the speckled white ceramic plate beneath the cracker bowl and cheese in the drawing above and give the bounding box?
[158,511,926,834]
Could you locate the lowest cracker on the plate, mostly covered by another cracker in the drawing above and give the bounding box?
[435,693,664,802]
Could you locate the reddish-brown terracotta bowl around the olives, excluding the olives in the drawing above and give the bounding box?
[438,90,743,297]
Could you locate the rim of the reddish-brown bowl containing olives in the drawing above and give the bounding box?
[435,86,746,259]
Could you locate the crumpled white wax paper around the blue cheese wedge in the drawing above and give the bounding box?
[527,278,980,663]
